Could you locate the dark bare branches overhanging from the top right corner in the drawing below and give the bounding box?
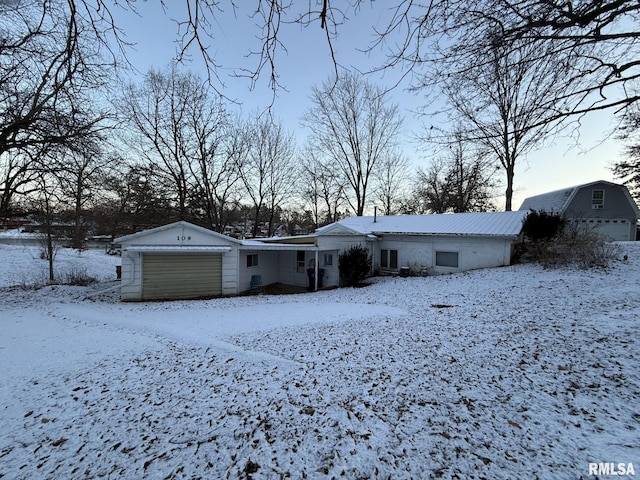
[370,0,640,123]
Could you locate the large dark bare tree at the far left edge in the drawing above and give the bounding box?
[0,1,108,221]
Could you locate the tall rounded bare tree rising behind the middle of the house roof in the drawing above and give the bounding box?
[303,72,402,216]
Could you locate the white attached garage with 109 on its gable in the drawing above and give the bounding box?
[115,222,240,301]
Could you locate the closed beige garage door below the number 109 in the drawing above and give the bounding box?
[142,253,222,300]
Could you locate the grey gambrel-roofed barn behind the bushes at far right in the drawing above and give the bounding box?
[520,180,640,241]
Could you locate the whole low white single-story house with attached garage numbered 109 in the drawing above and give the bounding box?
[115,211,527,300]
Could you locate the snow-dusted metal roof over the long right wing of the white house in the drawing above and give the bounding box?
[317,211,528,236]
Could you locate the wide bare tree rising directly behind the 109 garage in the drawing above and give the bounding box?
[123,65,230,220]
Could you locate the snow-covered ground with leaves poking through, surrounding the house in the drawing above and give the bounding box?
[0,242,640,479]
